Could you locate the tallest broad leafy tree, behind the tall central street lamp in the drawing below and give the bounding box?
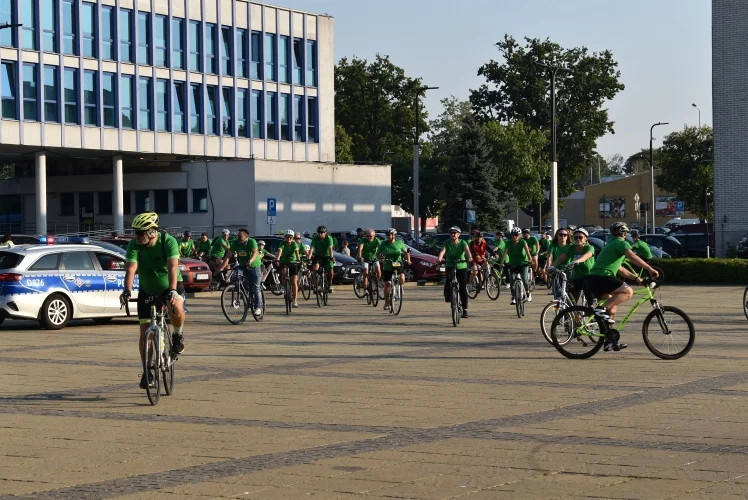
[470,35,624,220]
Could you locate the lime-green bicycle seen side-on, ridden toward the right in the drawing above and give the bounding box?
[551,279,696,360]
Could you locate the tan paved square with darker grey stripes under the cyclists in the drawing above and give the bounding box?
[0,286,748,500]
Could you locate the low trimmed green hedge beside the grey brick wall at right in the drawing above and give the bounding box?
[650,258,748,284]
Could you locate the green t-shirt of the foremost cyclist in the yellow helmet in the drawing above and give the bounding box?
[125,232,182,295]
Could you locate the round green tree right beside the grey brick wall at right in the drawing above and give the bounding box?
[655,125,714,219]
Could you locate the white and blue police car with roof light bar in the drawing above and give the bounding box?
[0,237,138,330]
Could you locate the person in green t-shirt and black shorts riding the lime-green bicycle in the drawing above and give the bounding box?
[585,222,657,351]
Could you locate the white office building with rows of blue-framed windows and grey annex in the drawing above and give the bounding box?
[0,0,390,233]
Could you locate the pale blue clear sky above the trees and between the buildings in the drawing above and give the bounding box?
[271,0,712,158]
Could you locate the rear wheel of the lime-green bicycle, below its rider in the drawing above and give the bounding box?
[551,306,605,359]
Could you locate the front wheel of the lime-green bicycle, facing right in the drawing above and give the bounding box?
[642,306,696,359]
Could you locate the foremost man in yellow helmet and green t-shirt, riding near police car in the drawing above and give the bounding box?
[120,212,184,389]
